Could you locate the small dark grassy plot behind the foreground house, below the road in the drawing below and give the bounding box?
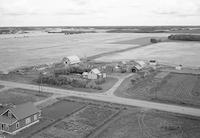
[0,88,52,104]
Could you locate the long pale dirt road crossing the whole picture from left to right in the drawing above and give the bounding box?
[0,81,200,117]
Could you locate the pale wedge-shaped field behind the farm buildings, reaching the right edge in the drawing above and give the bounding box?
[96,42,200,67]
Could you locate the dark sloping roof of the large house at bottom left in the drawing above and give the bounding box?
[9,102,40,120]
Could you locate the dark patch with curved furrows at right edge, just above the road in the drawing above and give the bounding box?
[152,73,200,107]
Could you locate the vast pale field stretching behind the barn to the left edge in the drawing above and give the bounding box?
[0,33,168,71]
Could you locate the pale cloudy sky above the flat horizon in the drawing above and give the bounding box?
[0,0,200,26]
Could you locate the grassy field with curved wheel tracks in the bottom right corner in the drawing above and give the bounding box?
[95,110,200,138]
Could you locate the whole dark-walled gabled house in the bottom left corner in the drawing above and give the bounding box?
[0,102,41,135]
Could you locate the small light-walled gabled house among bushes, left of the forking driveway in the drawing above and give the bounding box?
[88,68,106,80]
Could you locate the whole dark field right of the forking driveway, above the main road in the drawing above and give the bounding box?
[115,72,200,107]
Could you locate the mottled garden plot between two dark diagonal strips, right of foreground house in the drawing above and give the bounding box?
[34,105,117,138]
